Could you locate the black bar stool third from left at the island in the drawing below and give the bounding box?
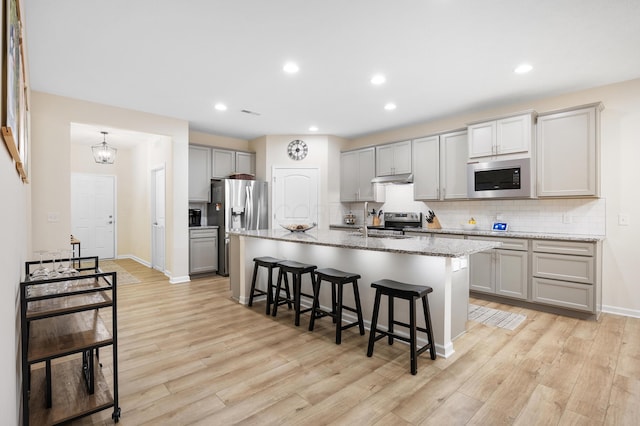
[309,268,364,345]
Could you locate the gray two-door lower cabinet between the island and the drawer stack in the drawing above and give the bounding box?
[469,237,529,300]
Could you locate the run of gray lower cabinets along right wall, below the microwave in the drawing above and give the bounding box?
[405,231,602,315]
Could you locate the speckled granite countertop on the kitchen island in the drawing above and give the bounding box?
[229,229,501,257]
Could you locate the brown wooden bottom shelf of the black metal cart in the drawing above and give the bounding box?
[29,356,119,425]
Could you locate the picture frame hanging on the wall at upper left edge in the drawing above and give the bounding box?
[2,0,29,182]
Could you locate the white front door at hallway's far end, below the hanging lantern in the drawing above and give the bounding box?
[71,173,116,259]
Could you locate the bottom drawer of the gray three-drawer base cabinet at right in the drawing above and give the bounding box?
[531,278,594,312]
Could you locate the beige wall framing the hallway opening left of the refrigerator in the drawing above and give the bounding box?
[31,92,189,282]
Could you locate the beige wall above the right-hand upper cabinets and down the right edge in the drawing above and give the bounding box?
[348,79,640,316]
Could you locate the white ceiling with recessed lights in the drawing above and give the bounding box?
[23,0,640,141]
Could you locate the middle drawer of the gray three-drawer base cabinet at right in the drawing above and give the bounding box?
[532,253,594,284]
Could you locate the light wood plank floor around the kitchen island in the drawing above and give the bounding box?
[67,260,640,426]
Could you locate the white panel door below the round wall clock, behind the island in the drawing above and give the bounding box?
[272,167,318,228]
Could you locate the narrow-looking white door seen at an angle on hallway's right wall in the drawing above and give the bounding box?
[151,166,165,272]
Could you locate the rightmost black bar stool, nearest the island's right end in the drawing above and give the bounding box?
[367,279,436,374]
